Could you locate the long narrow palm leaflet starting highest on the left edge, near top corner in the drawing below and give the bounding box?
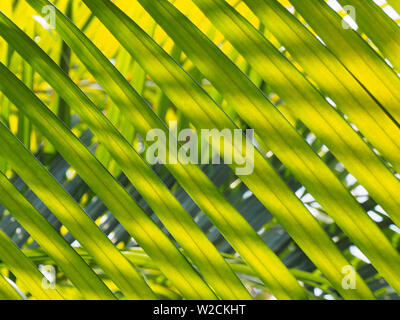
[0,9,250,299]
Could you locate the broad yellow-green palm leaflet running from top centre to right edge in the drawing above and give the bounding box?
[188,0,400,231]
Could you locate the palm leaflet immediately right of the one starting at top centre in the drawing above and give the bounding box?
[245,0,400,195]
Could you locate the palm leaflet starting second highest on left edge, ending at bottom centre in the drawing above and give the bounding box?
[0,59,219,298]
